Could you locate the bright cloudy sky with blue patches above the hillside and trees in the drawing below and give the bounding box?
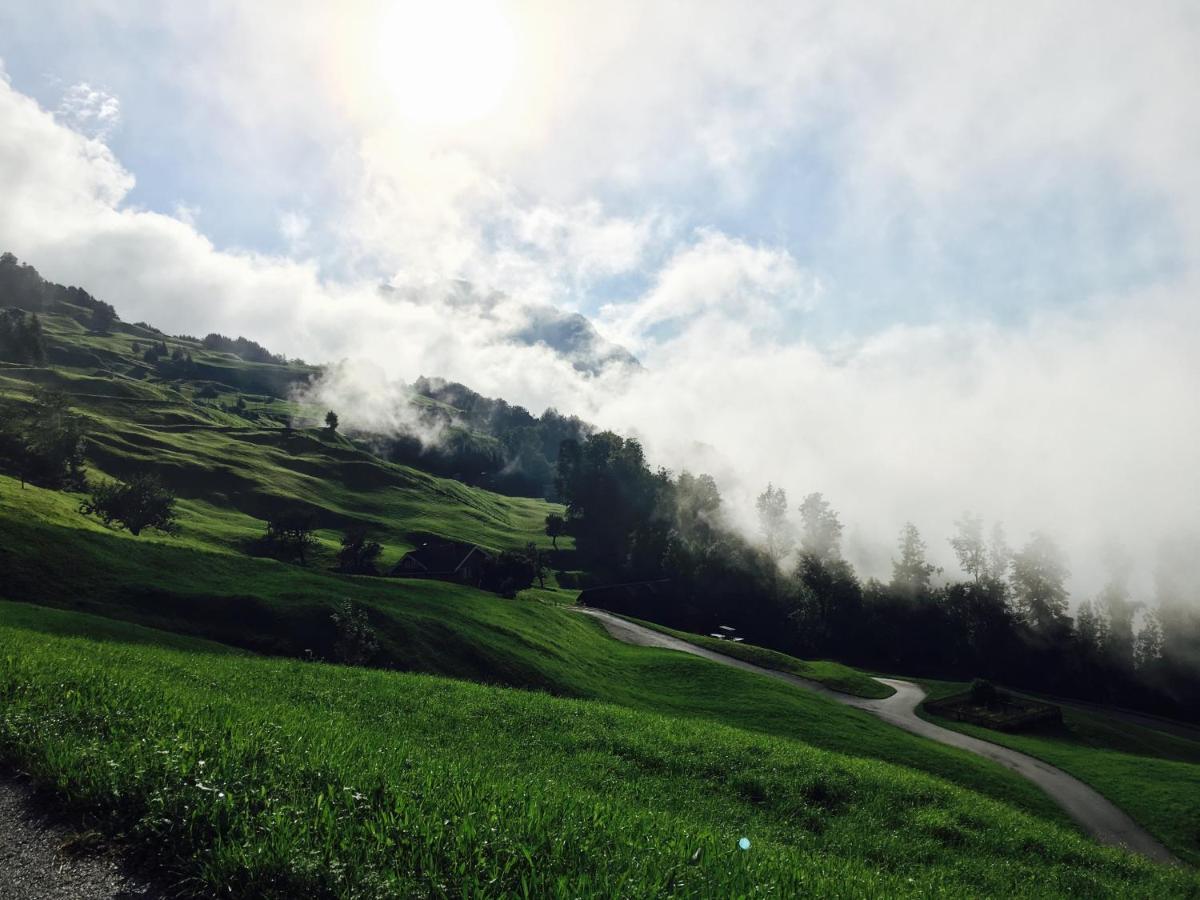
[0,0,1200,598]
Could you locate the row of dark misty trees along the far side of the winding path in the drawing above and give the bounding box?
[546,432,1200,716]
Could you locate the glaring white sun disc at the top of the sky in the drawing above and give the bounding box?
[374,0,516,125]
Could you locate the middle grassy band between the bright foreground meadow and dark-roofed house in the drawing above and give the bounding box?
[0,487,1063,821]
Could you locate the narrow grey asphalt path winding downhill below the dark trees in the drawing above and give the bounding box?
[580,608,1180,865]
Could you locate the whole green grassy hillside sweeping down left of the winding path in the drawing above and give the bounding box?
[0,301,1198,896]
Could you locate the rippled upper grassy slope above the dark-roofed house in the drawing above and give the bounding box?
[0,314,561,563]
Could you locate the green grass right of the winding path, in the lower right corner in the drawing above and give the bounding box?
[923,682,1200,865]
